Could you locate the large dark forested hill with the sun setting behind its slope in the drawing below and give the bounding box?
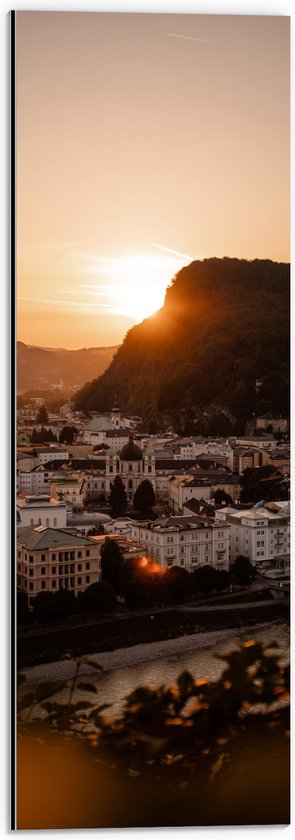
[76,257,290,433]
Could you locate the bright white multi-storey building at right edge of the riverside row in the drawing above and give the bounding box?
[216,502,290,569]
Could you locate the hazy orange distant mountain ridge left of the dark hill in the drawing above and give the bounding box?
[17,341,118,394]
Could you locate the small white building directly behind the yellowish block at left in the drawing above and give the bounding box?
[16,496,67,528]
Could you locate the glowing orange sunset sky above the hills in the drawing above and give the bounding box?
[16,12,290,348]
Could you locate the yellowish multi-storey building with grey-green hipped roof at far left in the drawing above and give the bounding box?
[17,526,101,604]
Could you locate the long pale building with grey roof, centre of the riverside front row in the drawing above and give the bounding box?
[132,516,230,571]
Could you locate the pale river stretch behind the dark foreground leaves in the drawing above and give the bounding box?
[23,620,290,716]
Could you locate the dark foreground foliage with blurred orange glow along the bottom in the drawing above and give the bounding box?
[18,640,289,828]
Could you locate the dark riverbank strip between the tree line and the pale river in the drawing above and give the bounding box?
[18,602,289,671]
